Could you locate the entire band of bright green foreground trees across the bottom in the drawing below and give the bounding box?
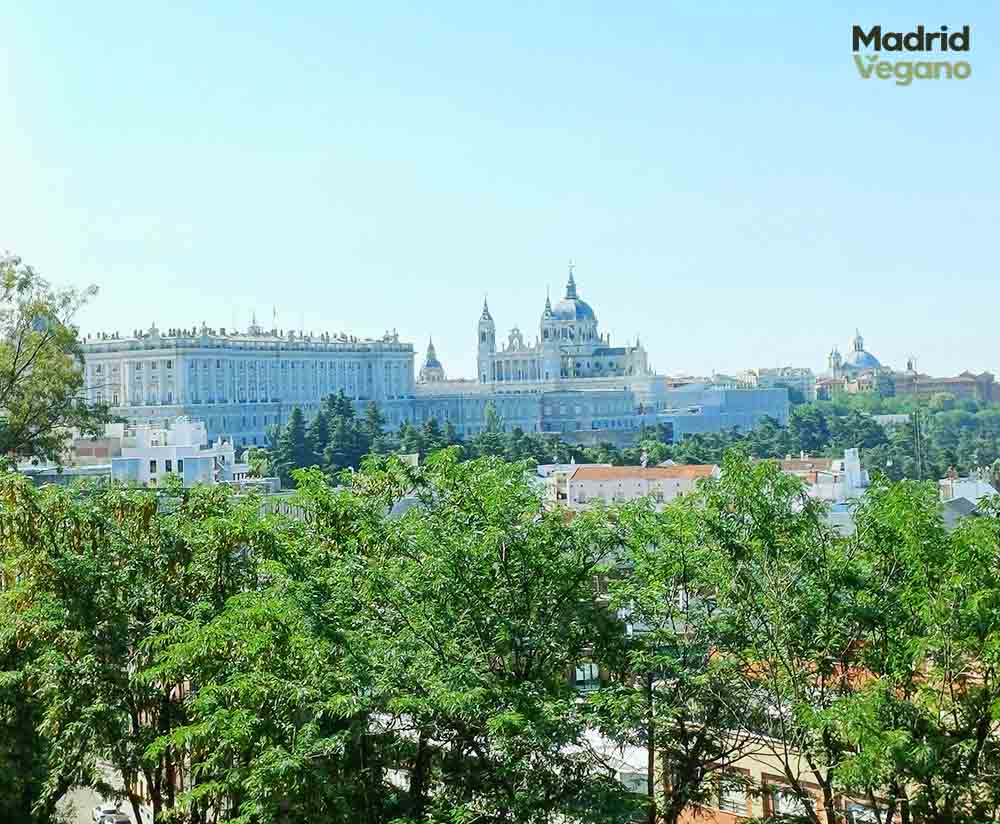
[0,444,1000,824]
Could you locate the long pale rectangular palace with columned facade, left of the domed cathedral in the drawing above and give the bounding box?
[83,326,414,446]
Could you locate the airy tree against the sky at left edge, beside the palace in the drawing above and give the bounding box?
[0,257,108,462]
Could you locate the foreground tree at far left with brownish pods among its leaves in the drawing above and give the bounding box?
[0,475,290,820]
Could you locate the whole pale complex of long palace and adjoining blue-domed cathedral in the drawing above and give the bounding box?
[84,267,788,446]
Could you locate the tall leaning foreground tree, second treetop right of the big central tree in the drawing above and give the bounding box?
[700,450,861,824]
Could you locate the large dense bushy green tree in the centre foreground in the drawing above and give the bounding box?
[311,450,624,823]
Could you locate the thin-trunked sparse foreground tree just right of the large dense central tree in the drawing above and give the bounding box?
[594,501,757,824]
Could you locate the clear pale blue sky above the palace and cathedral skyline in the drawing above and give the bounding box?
[0,0,1000,376]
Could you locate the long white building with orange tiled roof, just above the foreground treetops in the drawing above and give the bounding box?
[565,464,719,510]
